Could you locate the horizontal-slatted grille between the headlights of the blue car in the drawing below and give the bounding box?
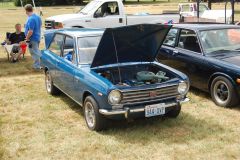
[121,85,179,105]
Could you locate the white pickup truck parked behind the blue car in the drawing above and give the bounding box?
[45,0,180,29]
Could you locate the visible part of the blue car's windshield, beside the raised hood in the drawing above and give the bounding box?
[78,36,101,64]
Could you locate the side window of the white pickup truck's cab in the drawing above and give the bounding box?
[95,2,119,17]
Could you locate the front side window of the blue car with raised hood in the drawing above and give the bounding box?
[63,36,75,62]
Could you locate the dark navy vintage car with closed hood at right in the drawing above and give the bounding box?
[158,24,240,107]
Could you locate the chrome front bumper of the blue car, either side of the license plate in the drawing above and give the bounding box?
[99,98,189,118]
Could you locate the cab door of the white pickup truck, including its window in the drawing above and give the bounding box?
[90,2,126,28]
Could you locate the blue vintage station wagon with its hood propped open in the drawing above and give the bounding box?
[41,25,189,131]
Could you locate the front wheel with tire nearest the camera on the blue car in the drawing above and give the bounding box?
[83,96,107,131]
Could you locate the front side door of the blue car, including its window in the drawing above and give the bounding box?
[57,36,76,96]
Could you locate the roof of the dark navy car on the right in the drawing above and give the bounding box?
[173,23,240,31]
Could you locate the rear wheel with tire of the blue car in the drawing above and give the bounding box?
[45,71,61,95]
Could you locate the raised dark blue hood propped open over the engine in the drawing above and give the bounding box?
[91,24,171,68]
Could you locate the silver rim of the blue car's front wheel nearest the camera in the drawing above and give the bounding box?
[85,102,96,128]
